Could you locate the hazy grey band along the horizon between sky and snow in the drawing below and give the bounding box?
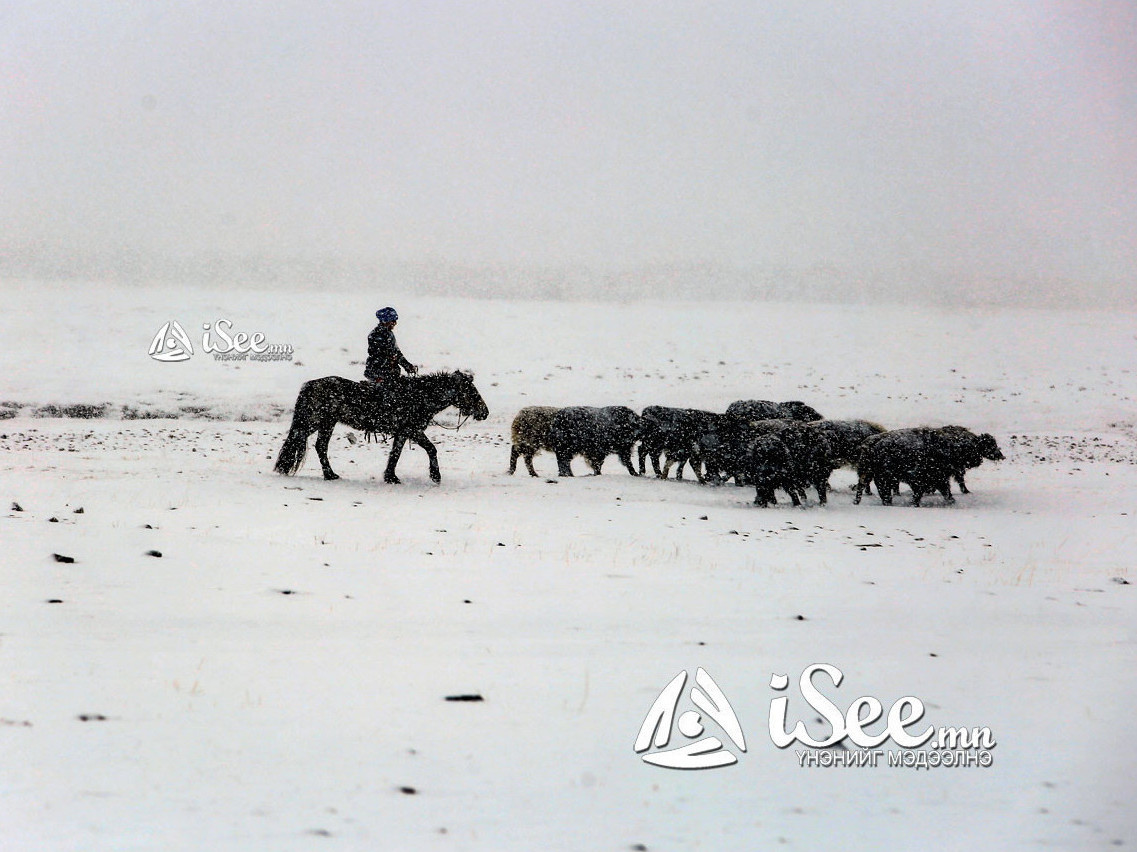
[0,250,1135,307]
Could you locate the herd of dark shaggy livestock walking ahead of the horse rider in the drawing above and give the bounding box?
[509,399,1004,506]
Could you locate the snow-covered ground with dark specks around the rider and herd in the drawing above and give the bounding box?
[0,282,1137,852]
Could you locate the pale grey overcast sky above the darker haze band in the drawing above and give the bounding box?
[0,0,1137,296]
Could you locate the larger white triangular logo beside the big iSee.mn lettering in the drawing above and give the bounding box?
[634,668,746,769]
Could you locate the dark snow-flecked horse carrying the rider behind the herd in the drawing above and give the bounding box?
[276,371,490,482]
